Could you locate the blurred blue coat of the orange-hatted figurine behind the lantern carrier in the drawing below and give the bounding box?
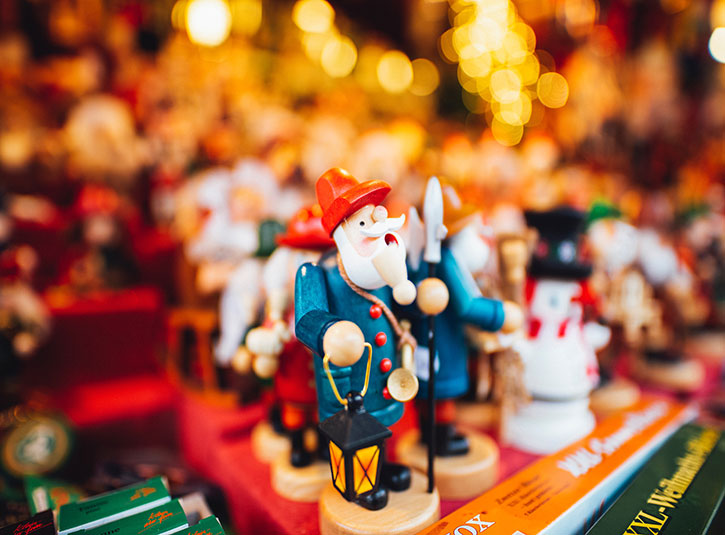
[410,246,504,399]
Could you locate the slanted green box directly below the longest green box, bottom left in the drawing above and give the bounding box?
[84,500,189,535]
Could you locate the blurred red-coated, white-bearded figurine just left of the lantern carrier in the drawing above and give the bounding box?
[243,205,335,502]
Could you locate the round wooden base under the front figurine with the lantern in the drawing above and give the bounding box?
[320,471,441,535]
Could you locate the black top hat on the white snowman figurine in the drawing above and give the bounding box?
[524,206,592,280]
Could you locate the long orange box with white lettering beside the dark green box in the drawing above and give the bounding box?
[421,398,696,535]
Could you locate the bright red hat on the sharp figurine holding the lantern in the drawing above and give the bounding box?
[316,167,390,236]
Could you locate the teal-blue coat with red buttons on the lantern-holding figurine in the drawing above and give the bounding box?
[295,256,403,426]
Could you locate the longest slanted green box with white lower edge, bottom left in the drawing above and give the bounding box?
[58,477,171,535]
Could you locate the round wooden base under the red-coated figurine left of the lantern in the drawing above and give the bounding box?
[271,455,330,502]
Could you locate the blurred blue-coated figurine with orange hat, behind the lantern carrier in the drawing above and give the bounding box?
[396,186,523,499]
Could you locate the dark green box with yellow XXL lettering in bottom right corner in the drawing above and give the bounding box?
[587,424,725,535]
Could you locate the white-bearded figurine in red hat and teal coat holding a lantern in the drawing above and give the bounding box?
[295,168,440,534]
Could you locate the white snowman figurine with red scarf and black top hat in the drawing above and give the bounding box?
[507,207,610,454]
